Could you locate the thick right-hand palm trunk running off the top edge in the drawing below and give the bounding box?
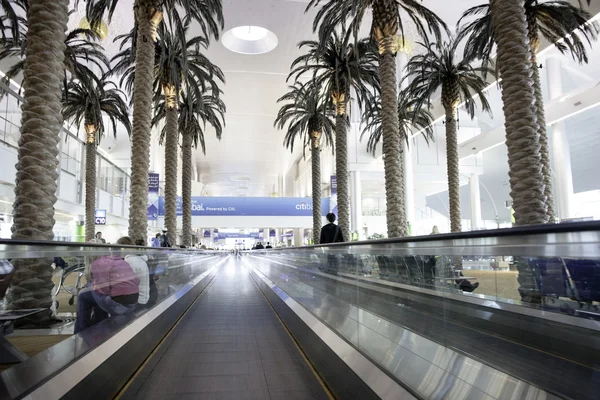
[490,0,548,225]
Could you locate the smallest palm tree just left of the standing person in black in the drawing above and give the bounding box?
[274,81,335,244]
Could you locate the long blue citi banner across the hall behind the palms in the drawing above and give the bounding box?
[158,196,329,217]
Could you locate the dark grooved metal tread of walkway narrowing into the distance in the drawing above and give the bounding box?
[121,257,328,400]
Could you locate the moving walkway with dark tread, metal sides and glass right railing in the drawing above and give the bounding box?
[0,223,600,400]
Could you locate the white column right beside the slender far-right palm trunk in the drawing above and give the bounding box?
[546,58,575,219]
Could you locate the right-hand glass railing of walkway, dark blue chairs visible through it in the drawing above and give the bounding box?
[245,223,600,399]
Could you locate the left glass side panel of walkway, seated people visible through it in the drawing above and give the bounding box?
[0,241,229,388]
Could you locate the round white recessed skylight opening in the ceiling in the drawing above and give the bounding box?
[221,25,279,54]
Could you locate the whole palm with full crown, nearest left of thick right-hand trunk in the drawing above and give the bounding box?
[406,39,491,232]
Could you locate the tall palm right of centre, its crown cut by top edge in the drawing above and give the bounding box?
[307,0,446,237]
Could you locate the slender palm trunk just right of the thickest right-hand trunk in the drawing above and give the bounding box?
[527,20,556,222]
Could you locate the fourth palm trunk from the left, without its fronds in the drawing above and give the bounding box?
[165,88,179,245]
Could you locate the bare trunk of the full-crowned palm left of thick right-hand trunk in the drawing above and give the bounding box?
[442,84,462,232]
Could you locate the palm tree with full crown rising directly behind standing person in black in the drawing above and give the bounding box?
[288,31,379,242]
